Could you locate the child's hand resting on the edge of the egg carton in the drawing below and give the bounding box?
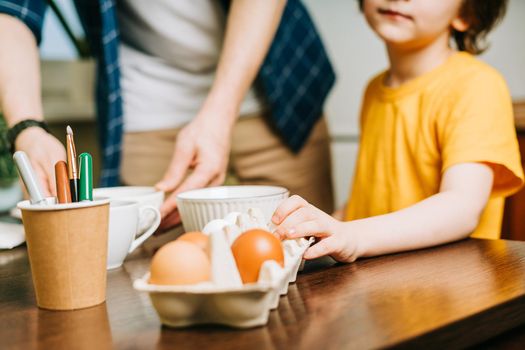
[272,196,357,262]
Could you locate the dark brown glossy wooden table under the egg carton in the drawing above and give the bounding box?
[0,240,525,350]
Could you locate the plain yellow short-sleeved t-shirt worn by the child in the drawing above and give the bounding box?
[345,52,523,238]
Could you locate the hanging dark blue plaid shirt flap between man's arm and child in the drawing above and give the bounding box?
[257,0,335,152]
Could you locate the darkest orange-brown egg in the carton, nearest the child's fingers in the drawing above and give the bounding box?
[232,229,284,283]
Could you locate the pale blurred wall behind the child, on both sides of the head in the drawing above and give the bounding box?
[303,0,525,205]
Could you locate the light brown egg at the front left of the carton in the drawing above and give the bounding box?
[149,240,211,284]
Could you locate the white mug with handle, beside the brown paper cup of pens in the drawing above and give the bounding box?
[107,200,161,269]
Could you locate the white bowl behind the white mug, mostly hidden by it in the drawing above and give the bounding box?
[93,186,164,234]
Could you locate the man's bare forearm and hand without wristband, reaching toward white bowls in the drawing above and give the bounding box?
[152,0,286,227]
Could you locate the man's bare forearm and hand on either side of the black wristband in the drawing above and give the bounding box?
[0,14,66,196]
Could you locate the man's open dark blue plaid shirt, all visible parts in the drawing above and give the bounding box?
[0,0,335,186]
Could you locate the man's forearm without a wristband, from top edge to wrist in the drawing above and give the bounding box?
[207,0,286,123]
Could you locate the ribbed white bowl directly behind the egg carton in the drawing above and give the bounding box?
[177,186,289,232]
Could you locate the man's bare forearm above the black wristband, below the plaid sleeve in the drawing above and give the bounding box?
[0,14,43,126]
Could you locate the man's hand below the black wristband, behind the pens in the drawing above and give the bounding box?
[15,127,66,197]
